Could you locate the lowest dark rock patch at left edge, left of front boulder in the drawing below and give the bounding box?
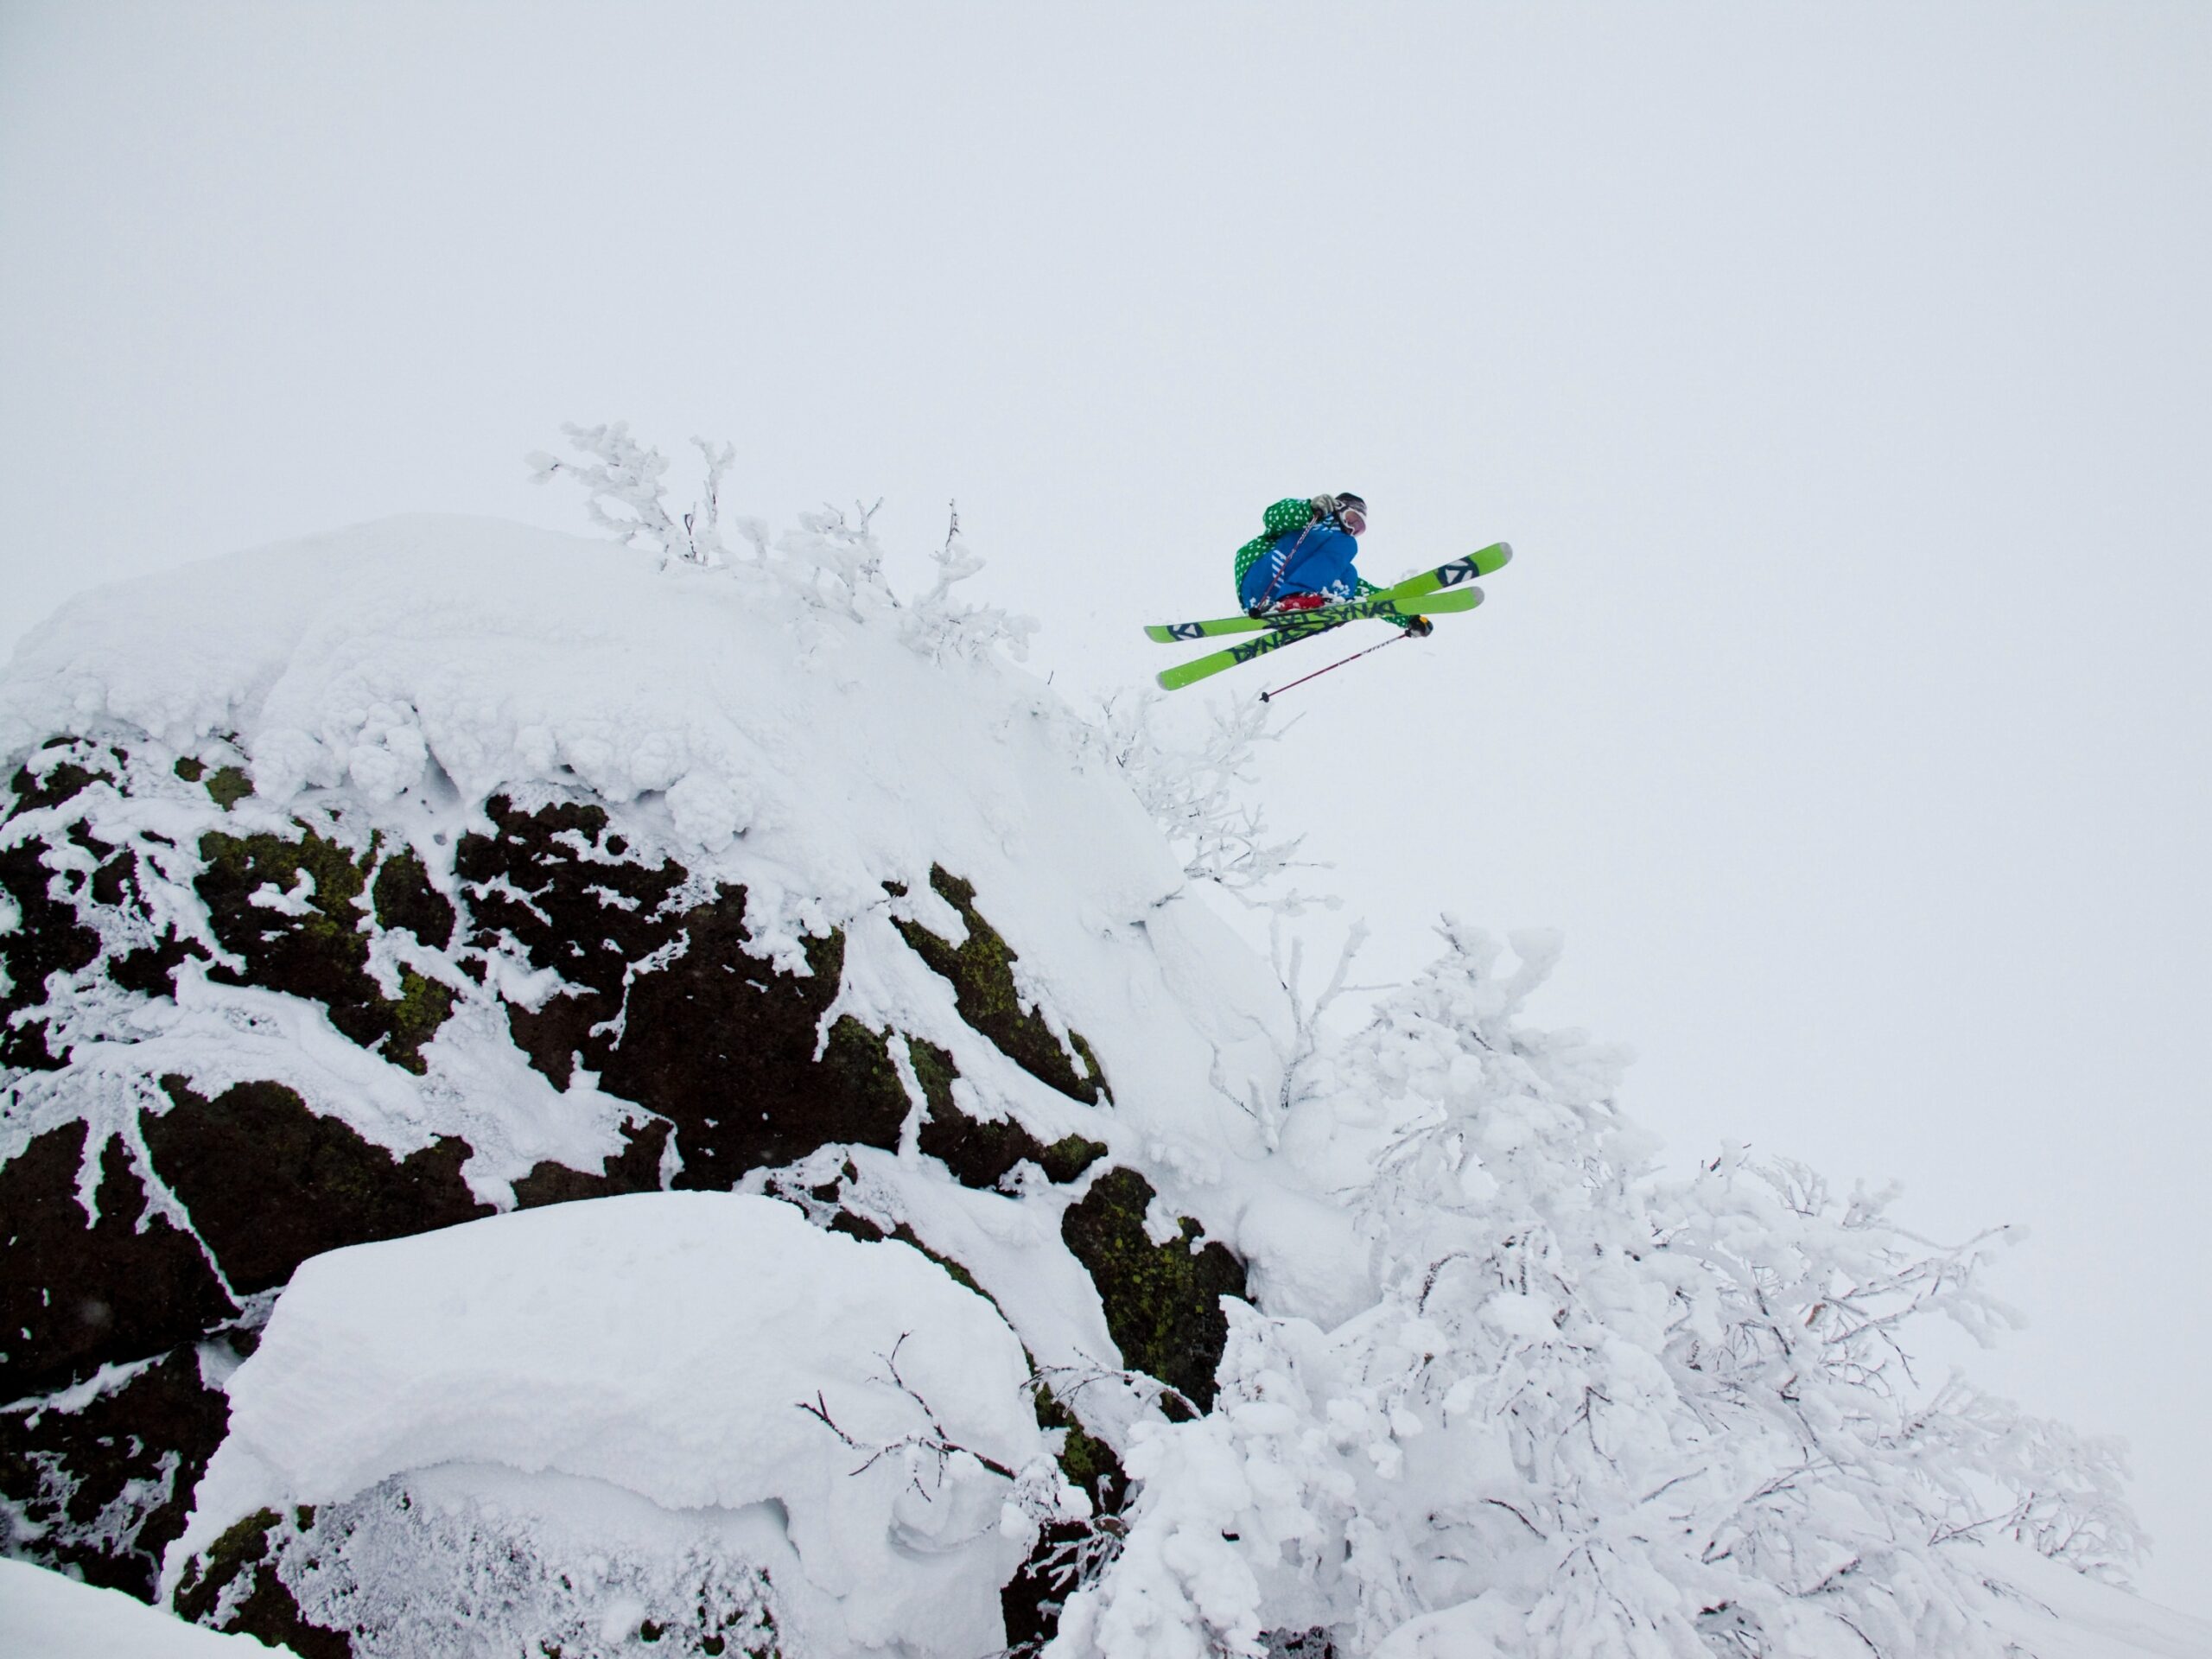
[0,1347,230,1601]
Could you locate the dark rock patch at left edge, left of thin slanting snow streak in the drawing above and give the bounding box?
[0,1123,237,1398]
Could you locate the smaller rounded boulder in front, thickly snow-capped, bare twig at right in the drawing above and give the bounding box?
[181,1192,1059,1655]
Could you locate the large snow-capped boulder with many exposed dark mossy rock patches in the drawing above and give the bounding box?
[0,520,1300,1654]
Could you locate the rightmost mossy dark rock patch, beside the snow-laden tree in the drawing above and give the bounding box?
[1059,1168,1245,1415]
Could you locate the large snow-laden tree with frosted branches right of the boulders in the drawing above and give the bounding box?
[1046,920,2137,1659]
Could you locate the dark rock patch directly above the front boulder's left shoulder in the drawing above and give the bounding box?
[142,1077,493,1296]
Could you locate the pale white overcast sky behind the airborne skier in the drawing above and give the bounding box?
[0,0,2212,1612]
